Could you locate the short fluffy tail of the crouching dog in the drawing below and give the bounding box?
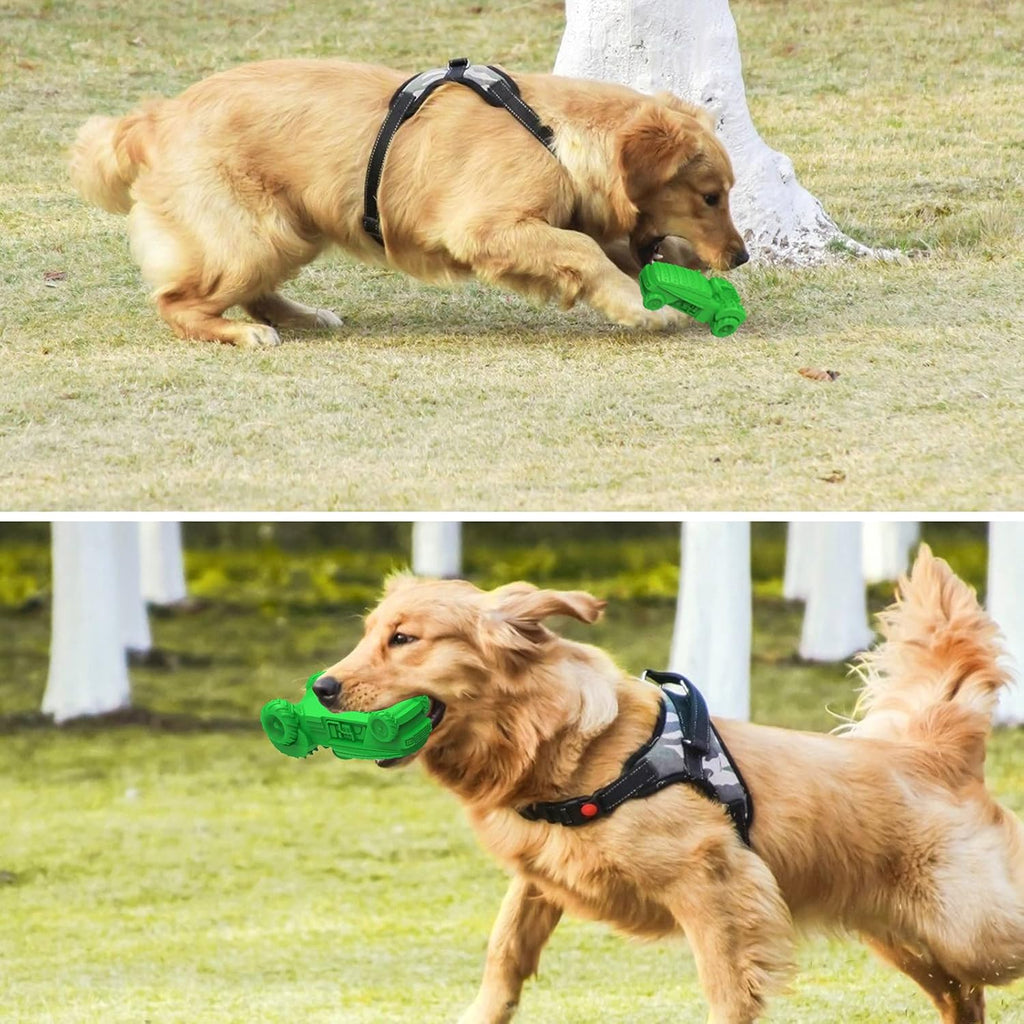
[70,104,156,213]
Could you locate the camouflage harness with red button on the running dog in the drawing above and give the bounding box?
[519,669,754,846]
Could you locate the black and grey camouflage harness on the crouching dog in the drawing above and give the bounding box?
[362,57,555,245]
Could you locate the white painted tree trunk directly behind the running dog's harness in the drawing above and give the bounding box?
[669,521,751,720]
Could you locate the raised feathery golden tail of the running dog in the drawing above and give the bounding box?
[850,544,1010,777]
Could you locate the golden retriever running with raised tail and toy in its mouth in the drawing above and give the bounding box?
[315,547,1024,1024]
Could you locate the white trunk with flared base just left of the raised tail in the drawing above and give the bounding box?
[800,522,873,662]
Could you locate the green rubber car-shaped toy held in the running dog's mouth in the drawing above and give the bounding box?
[259,672,433,761]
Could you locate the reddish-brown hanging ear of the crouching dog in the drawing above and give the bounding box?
[618,102,703,203]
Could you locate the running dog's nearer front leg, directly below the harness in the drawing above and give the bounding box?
[666,837,795,1024]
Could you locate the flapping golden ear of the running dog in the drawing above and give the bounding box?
[480,583,605,666]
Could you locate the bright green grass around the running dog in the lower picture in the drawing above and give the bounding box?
[0,528,1024,1024]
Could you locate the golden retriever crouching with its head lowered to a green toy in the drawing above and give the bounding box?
[71,60,748,346]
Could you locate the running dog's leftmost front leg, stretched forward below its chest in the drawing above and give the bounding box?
[459,876,562,1024]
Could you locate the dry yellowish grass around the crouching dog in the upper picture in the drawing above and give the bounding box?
[0,0,1024,510]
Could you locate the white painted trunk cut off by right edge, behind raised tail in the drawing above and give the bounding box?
[987,520,1024,725]
